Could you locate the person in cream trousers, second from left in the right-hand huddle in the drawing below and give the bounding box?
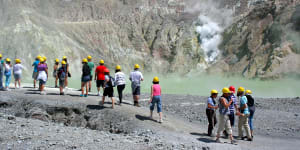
[216,87,236,144]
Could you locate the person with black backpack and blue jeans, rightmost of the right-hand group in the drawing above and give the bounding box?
[246,90,255,139]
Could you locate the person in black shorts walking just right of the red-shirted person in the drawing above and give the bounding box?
[102,69,115,109]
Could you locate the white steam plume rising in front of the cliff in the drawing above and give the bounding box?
[187,0,233,64]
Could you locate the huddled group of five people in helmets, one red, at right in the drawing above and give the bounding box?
[206,86,255,144]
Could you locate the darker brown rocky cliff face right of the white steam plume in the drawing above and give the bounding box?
[214,0,300,78]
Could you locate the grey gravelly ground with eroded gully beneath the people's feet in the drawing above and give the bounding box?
[0,88,300,150]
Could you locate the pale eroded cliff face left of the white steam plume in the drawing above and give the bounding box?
[0,0,205,75]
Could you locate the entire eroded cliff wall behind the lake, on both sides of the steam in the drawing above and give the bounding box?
[0,0,300,77]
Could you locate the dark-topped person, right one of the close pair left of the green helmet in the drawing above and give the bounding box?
[57,61,67,95]
